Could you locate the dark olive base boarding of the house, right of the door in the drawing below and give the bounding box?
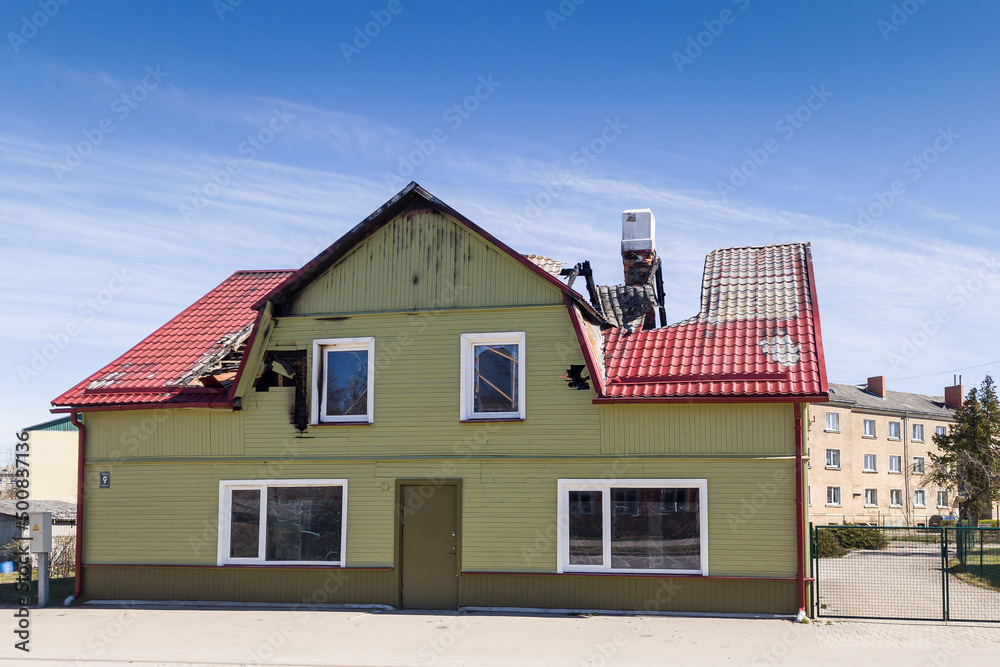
[458,574,798,614]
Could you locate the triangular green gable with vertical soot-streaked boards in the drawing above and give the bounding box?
[285,203,563,315]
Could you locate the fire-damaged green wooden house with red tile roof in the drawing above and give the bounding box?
[54,183,828,613]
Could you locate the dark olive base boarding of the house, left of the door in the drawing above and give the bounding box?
[83,566,399,606]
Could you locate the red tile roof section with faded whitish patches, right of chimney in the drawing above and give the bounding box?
[598,243,827,400]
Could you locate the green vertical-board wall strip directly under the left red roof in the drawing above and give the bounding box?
[84,408,243,461]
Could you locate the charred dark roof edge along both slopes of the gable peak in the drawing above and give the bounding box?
[252,181,603,320]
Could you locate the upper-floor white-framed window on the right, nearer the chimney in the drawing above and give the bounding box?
[459,331,525,421]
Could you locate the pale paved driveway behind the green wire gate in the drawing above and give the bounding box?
[818,542,1000,620]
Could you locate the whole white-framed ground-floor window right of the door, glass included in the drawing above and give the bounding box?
[557,479,708,575]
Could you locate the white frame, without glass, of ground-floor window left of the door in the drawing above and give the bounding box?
[216,479,347,567]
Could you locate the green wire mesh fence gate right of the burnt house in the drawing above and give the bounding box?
[812,526,1000,621]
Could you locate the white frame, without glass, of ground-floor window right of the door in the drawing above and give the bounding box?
[556,479,709,577]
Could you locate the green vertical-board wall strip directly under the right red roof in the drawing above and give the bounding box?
[600,403,795,455]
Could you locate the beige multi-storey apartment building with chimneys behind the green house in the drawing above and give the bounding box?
[809,376,988,526]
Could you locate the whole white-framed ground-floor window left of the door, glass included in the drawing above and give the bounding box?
[217,479,347,567]
